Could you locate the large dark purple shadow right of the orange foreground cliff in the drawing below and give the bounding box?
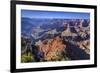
[65,43,90,60]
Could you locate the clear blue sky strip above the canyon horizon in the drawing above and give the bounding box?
[21,9,90,19]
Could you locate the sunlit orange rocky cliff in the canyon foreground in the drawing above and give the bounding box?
[39,37,66,61]
